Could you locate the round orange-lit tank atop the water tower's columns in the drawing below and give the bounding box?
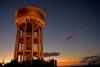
[16,6,46,27]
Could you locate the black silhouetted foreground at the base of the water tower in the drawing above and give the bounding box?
[0,60,57,67]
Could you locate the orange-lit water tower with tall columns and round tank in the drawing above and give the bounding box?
[14,6,46,62]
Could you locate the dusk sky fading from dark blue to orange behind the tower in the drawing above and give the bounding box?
[0,0,100,62]
